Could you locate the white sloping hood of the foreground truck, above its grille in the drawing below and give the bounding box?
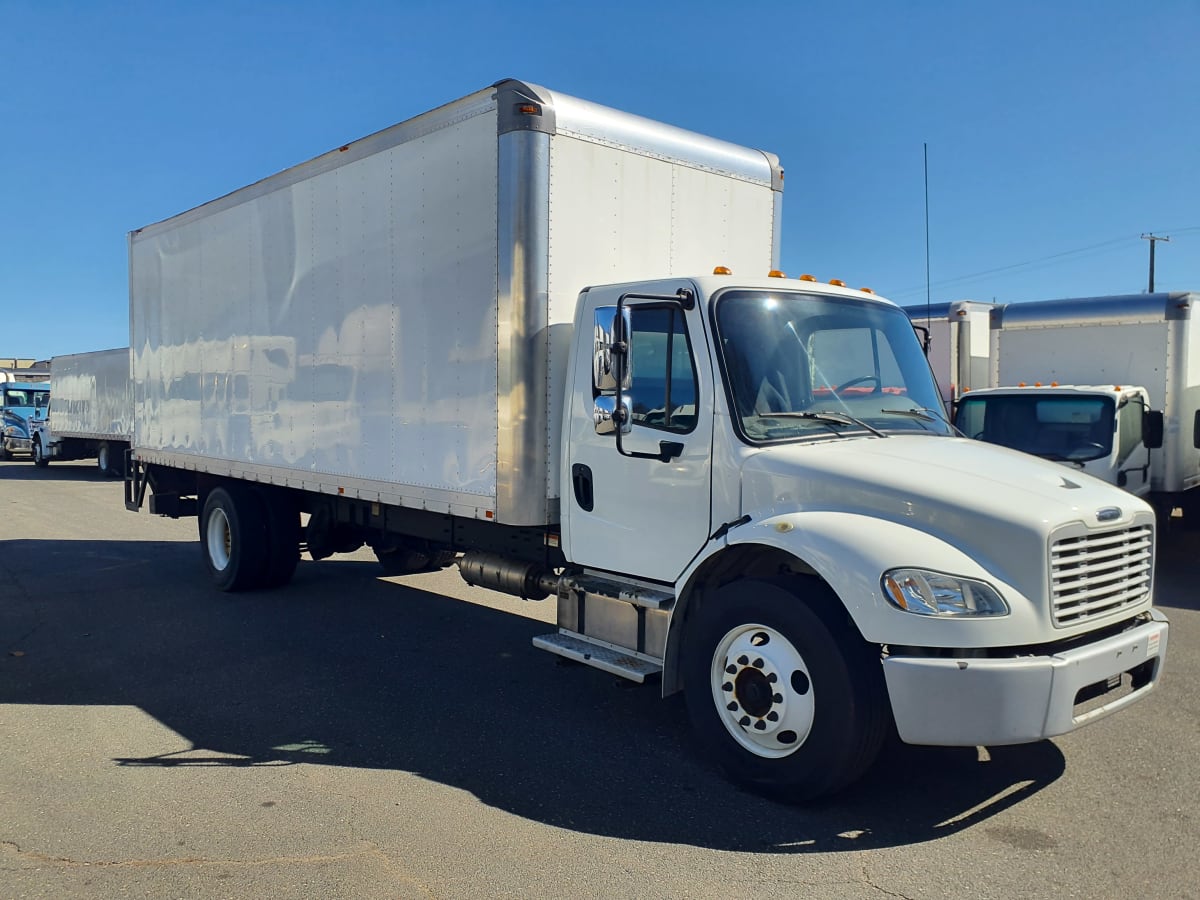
[742,434,1150,558]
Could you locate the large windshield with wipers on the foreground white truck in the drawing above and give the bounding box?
[715,290,950,442]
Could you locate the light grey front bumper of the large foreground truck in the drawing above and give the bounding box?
[883,610,1168,746]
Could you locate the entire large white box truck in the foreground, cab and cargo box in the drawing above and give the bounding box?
[126,80,1168,799]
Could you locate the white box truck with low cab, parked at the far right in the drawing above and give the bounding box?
[955,292,1200,527]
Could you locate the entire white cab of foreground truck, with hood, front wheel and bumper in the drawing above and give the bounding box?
[549,276,1166,796]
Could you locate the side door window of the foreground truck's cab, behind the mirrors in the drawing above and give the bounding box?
[628,306,697,433]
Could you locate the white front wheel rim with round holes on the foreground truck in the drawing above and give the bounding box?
[710,624,816,760]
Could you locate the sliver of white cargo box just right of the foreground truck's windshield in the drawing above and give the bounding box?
[904,300,995,407]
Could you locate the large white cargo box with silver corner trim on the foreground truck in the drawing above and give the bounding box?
[130,80,782,526]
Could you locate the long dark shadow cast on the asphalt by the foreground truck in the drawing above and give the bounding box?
[0,540,1064,853]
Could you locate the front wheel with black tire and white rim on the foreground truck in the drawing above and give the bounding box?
[683,580,888,802]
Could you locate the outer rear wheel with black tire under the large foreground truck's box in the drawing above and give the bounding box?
[200,485,268,592]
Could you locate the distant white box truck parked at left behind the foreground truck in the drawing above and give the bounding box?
[30,347,133,475]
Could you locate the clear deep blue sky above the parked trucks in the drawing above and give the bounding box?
[0,0,1200,358]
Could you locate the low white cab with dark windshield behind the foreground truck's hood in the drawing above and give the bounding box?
[954,385,1163,497]
